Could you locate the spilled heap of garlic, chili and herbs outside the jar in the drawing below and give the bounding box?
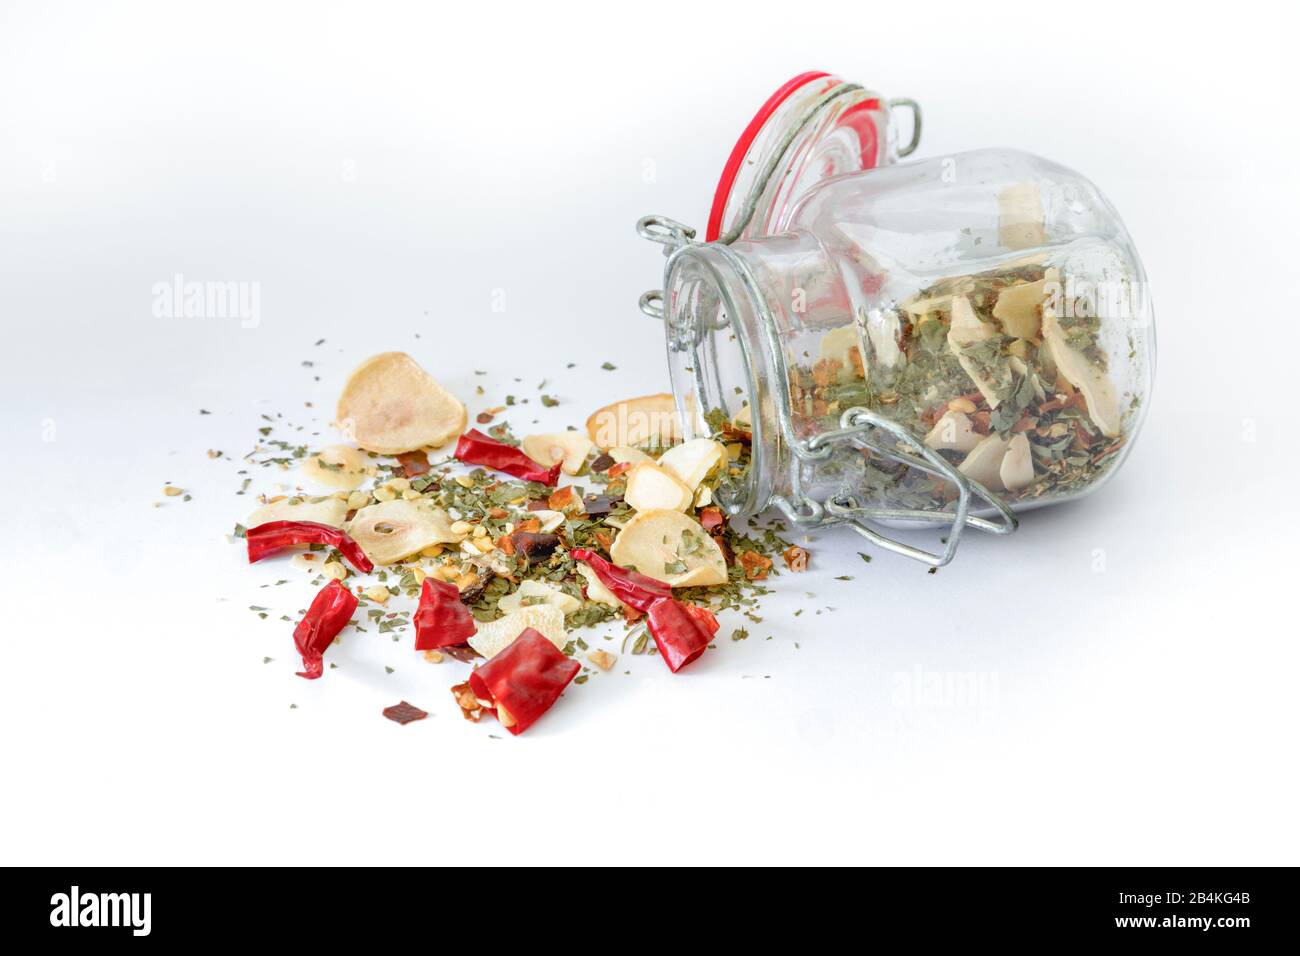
[218,352,809,734]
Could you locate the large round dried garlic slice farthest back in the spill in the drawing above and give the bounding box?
[334,352,468,455]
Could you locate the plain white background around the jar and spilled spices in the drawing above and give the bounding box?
[0,3,1300,865]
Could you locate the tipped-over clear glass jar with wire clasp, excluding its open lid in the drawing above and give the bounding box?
[641,150,1154,566]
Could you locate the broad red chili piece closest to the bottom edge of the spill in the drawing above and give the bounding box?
[467,627,582,734]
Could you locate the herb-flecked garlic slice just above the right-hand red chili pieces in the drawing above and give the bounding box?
[610,509,727,588]
